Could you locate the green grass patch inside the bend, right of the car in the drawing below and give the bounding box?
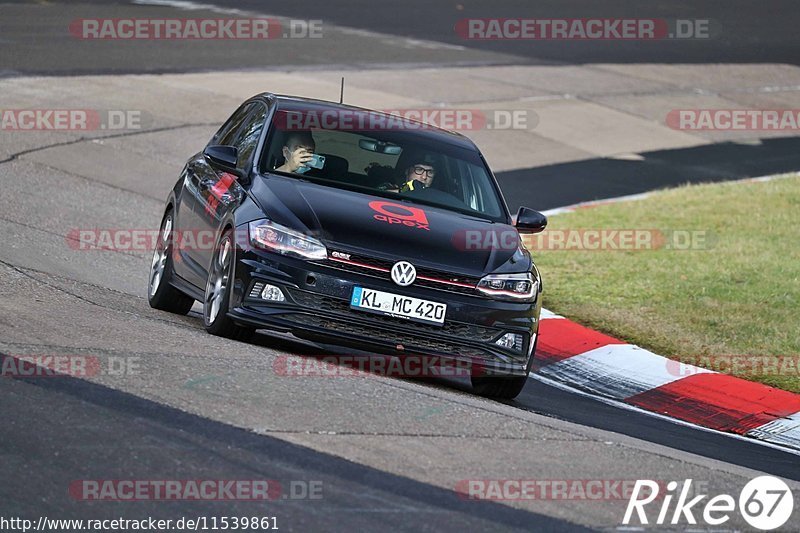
[533,176,800,392]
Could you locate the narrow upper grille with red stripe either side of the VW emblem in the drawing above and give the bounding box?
[318,249,483,296]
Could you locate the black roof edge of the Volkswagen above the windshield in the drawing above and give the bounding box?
[251,93,478,151]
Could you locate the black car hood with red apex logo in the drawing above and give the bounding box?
[251,175,530,276]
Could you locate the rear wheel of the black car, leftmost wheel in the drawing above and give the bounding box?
[147,208,194,315]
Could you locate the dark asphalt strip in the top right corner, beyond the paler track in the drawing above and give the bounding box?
[203,0,800,64]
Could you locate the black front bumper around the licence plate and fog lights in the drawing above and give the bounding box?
[228,241,541,376]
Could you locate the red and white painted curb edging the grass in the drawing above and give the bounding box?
[531,175,800,451]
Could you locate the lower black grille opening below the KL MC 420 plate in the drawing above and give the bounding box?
[288,289,504,342]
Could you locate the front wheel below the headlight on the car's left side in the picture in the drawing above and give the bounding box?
[203,229,255,341]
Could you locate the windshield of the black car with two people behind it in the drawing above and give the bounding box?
[259,108,507,222]
